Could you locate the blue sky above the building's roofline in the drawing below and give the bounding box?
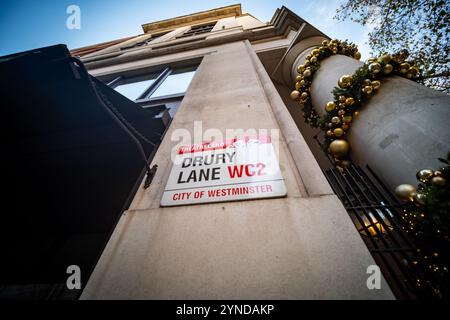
[0,0,370,59]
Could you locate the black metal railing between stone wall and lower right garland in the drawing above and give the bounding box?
[324,165,436,299]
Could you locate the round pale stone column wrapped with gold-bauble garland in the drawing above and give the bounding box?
[285,41,450,189]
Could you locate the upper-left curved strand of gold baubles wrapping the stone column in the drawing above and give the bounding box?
[291,39,361,127]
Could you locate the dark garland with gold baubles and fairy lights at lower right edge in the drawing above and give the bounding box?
[395,152,450,298]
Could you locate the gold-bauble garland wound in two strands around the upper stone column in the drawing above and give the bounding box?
[291,40,420,169]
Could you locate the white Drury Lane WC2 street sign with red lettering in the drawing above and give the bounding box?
[161,136,286,206]
